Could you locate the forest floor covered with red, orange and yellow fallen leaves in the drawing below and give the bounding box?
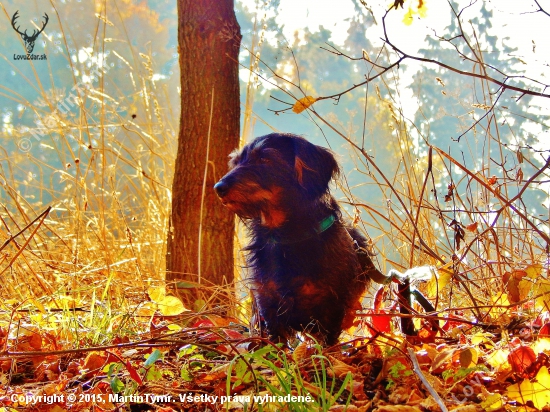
[0,280,550,412]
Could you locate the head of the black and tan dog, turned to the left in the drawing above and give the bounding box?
[214,133,339,227]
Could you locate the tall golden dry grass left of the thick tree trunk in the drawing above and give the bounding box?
[0,0,179,338]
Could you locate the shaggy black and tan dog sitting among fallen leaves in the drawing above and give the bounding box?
[214,133,383,344]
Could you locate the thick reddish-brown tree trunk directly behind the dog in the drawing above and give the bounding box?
[166,0,241,294]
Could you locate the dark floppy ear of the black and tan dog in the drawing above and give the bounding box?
[293,137,340,197]
